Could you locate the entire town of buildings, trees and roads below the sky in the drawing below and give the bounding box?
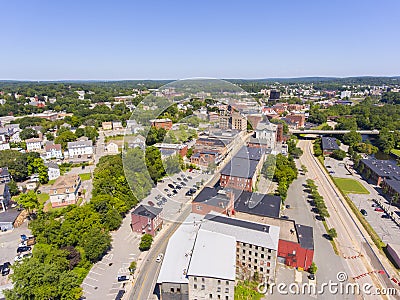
[0,77,400,300]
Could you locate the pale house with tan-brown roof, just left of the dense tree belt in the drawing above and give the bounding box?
[49,174,81,207]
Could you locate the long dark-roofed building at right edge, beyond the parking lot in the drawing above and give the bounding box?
[358,158,400,186]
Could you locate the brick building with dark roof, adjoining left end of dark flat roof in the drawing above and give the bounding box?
[192,187,234,215]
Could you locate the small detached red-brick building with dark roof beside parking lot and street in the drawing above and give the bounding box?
[131,204,163,236]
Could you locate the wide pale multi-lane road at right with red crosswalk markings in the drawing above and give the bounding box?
[298,140,395,299]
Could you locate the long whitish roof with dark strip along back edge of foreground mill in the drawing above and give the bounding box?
[201,213,280,250]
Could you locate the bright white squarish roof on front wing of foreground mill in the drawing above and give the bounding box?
[187,229,236,280]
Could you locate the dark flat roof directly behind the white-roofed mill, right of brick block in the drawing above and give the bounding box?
[235,191,282,218]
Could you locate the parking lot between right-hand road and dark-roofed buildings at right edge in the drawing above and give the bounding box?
[325,157,400,244]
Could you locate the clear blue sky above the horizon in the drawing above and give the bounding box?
[0,0,400,80]
